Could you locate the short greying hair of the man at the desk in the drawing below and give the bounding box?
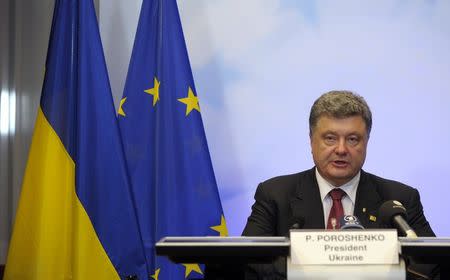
[309,90,372,136]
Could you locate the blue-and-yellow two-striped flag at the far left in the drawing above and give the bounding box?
[4,0,149,280]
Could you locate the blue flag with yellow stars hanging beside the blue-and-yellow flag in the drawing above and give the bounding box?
[119,0,227,279]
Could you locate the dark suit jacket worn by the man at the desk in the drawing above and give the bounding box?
[242,168,436,279]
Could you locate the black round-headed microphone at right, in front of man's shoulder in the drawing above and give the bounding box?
[379,200,417,238]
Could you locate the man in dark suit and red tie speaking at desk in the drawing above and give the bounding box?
[243,91,434,274]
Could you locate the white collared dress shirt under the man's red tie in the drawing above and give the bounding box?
[316,168,361,228]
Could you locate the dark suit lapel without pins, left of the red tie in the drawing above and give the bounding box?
[290,168,325,229]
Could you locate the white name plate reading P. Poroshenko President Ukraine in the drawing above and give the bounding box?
[291,229,399,265]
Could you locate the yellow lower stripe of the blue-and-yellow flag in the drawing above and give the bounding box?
[4,108,119,280]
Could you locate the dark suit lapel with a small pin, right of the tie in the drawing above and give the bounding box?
[354,170,383,228]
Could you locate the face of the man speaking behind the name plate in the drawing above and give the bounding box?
[310,116,369,187]
